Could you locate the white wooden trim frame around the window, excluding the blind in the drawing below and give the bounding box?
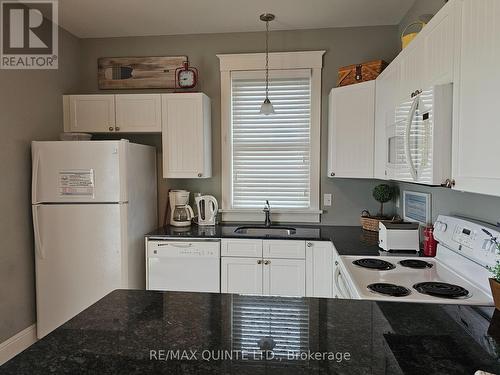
[217,51,325,223]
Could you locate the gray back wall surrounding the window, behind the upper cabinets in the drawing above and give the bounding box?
[78,26,398,225]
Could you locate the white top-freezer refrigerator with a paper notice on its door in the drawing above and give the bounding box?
[32,140,157,338]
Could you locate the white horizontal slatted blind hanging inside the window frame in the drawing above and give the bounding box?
[231,70,311,209]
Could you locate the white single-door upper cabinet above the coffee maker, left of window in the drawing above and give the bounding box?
[162,93,212,178]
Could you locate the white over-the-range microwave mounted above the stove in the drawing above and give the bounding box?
[386,83,453,185]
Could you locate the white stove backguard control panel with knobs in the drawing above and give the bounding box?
[434,215,500,266]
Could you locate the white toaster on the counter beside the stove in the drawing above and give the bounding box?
[378,221,420,252]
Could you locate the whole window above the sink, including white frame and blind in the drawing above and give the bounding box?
[219,51,323,222]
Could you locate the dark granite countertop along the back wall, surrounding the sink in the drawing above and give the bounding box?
[146,223,379,256]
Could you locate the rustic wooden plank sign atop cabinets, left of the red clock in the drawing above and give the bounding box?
[97,56,188,90]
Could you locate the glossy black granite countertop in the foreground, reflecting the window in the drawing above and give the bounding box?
[0,290,500,375]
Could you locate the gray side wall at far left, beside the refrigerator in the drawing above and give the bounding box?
[0,32,79,342]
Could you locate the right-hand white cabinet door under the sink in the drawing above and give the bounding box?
[263,259,306,297]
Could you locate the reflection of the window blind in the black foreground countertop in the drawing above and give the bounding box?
[232,296,309,358]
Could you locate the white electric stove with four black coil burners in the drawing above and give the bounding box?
[334,216,500,305]
